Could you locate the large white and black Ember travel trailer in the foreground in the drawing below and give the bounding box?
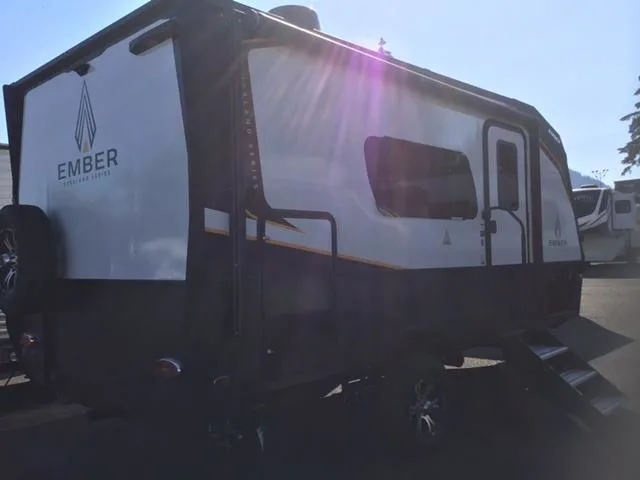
[0,0,619,462]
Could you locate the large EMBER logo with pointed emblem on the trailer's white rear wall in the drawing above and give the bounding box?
[58,82,118,186]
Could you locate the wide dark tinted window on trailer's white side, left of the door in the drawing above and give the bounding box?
[364,137,478,219]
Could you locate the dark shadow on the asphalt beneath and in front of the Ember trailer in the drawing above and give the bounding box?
[0,365,640,480]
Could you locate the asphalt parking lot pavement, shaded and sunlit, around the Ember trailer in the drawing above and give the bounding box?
[0,266,640,480]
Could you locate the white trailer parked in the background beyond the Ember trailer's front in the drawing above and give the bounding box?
[573,185,640,262]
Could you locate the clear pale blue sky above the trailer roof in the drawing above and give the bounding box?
[0,0,640,183]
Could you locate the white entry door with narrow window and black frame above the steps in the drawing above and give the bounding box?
[485,125,530,265]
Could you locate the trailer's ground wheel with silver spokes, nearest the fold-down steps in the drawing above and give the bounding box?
[377,368,448,456]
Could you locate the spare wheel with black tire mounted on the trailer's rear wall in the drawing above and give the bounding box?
[0,205,55,316]
